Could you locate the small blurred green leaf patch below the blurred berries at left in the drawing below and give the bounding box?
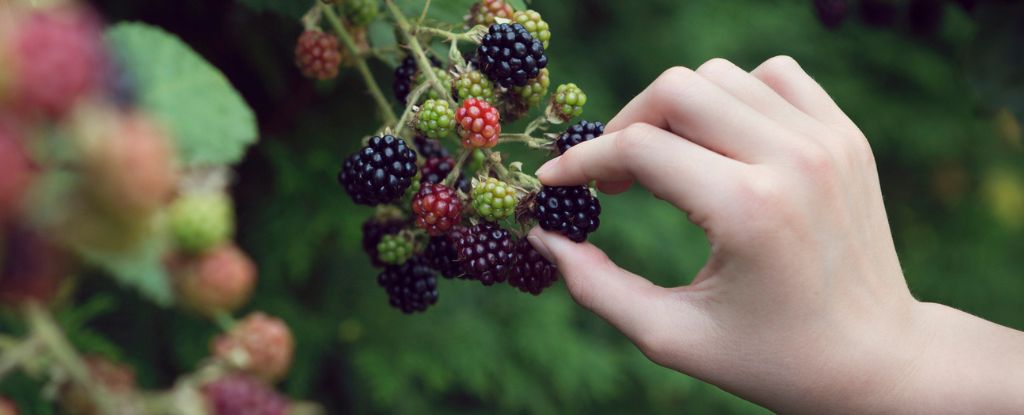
[77,235,174,306]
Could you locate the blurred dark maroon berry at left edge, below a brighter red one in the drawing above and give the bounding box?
[0,222,70,303]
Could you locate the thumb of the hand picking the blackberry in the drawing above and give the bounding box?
[527,227,670,341]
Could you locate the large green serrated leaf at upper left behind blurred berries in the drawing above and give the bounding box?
[106,23,257,166]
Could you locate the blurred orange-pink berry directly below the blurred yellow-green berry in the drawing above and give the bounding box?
[168,244,256,317]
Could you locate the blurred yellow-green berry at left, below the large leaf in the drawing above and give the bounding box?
[167,192,234,253]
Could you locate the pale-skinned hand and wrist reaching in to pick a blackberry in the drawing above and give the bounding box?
[529,56,1024,414]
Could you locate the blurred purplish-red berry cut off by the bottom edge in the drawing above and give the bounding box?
[203,375,289,415]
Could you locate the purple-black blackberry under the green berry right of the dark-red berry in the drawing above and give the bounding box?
[454,222,515,286]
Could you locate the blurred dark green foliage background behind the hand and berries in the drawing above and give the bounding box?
[4,0,1024,413]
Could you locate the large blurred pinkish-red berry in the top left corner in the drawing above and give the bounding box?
[5,7,105,118]
